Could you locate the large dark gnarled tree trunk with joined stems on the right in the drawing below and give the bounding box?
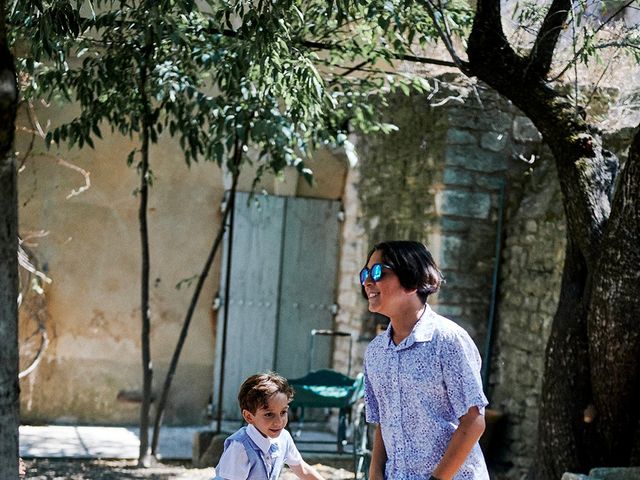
[467,0,640,480]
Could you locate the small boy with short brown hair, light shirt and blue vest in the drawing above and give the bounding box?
[214,372,324,480]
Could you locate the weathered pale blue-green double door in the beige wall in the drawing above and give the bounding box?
[213,193,340,419]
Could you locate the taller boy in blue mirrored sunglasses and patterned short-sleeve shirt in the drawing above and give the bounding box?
[360,241,489,480]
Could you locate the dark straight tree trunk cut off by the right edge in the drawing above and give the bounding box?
[588,125,640,465]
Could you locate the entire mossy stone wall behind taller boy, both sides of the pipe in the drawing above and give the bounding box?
[335,78,631,479]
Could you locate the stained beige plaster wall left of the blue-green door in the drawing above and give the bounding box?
[16,105,346,424]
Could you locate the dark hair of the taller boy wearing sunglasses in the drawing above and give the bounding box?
[362,240,443,303]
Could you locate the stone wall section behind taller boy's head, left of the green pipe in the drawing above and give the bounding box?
[336,79,539,365]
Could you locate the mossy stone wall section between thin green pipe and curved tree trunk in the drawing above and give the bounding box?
[488,155,565,478]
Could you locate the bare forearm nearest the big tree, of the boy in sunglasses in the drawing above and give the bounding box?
[433,407,485,480]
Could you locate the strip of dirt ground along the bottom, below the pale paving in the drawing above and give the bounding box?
[25,458,353,480]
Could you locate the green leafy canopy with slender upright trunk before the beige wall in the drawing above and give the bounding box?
[8,0,432,465]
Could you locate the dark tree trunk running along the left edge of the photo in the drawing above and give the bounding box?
[0,0,20,478]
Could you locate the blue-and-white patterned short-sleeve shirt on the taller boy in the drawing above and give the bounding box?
[365,305,489,480]
